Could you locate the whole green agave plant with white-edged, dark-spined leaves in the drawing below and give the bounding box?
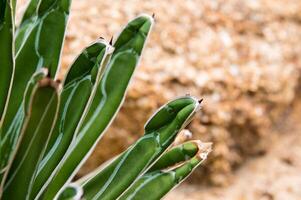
[0,0,210,200]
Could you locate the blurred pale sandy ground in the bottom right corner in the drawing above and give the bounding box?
[165,99,301,200]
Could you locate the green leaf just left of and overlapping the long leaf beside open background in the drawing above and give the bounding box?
[31,41,112,198]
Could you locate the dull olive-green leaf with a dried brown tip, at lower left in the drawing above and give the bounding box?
[3,77,59,199]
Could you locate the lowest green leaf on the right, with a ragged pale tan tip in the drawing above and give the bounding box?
[118,141,211,200]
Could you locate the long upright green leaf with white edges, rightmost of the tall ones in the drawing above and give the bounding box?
[39,15,153,199]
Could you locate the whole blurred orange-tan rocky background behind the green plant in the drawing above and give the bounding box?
[18,0,301,200]
